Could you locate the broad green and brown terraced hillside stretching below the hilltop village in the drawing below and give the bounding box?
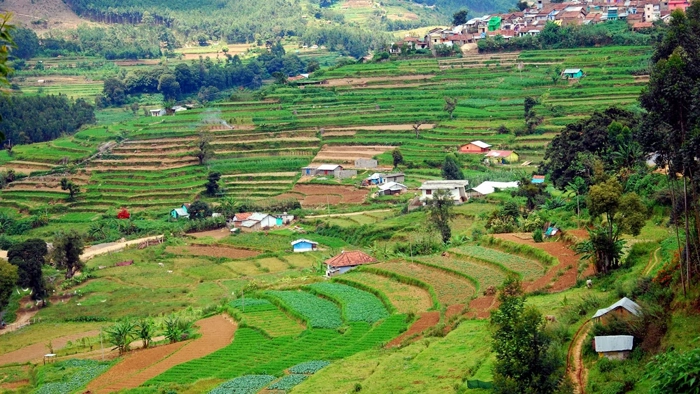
[0,47,650,226]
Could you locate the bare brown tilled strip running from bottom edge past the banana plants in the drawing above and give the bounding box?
[88,315,238,393]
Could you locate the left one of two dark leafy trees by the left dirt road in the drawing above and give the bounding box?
[7,238,48,300]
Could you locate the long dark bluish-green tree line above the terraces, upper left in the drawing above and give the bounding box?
[96,43,307,106]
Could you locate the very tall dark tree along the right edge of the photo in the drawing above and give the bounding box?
[639,2,700,284]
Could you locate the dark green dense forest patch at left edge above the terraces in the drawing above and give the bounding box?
[0,95,95,145]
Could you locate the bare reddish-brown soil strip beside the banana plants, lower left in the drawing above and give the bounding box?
[90,315,238,393]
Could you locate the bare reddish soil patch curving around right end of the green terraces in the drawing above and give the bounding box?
[495,234,581,292]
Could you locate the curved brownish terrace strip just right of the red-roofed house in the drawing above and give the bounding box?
[373,261,476,306]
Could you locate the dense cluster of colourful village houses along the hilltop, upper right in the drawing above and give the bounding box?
[390,0,690,53]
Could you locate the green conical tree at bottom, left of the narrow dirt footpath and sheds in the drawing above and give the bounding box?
[491,276,563,394]
